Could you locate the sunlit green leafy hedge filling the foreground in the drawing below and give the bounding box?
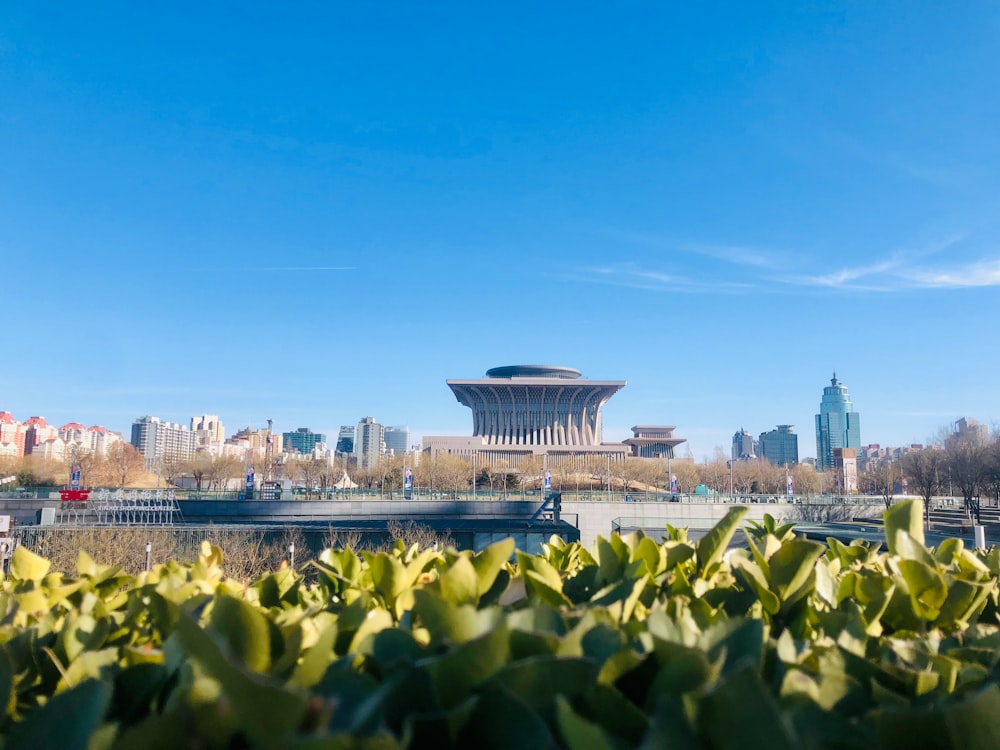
[0,502,1000,750]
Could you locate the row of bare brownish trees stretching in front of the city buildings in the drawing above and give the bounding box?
[0,424,1000,511]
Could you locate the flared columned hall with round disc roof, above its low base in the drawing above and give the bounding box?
[447,365,625,447]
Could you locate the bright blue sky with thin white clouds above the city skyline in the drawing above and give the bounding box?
[0,0,1000,459]
